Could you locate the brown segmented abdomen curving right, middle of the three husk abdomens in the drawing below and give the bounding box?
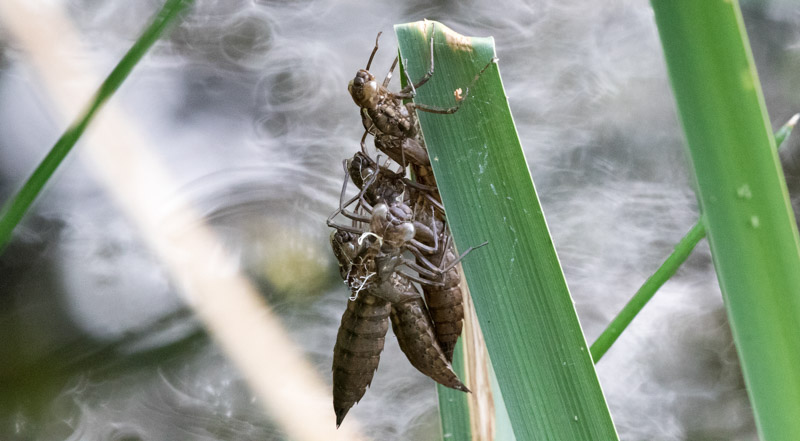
[391,274,469,392]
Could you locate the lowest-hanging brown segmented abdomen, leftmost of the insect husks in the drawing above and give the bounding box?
[333,293,391,427]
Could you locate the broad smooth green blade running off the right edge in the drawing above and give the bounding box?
[652,0,800,440]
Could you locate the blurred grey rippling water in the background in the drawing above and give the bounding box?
[0,0,800,441]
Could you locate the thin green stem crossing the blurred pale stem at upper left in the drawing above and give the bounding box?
[0,0,193,252]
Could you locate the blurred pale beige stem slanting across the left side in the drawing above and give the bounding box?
[0,0,365,441]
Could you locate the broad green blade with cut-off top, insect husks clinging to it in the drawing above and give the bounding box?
[395,22,617,441]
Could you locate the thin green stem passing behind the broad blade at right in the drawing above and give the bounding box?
[590,114,800,363]
